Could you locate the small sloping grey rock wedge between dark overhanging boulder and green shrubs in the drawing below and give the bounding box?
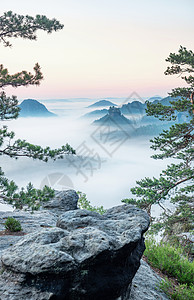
[129,260,169,300]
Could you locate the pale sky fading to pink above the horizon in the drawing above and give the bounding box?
[0,0,194,100]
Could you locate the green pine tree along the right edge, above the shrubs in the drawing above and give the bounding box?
[123,46,194,252]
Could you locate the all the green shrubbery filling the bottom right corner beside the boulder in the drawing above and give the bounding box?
[144,239,194,300]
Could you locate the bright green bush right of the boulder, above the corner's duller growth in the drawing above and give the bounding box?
[144,240,194,286]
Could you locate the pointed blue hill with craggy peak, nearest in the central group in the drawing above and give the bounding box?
[93,106,133,127]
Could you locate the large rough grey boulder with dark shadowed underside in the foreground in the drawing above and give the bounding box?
[0,205,149,300]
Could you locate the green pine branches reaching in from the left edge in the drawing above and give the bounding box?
[0,11,75,210]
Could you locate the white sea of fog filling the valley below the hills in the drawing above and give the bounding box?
[0,99,169,214]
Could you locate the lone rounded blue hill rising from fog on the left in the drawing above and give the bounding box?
[19,99,56,117]
